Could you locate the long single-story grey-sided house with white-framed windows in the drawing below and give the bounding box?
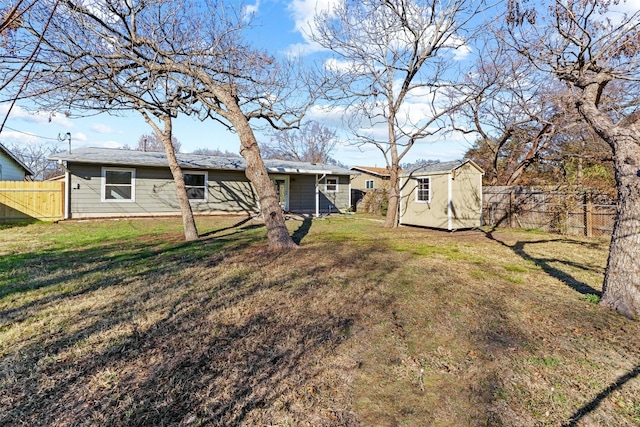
[49,148,351,219]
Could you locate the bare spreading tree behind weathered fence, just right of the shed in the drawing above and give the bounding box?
[451,45,564,185]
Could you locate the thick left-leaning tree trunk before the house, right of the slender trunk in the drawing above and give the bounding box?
[233,110,298,250]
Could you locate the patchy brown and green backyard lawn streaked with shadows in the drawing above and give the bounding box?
[0,216,640,426]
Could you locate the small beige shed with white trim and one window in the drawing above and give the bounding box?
[399,160,484,230]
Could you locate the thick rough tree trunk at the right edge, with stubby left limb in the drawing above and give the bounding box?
[578,83,640,318]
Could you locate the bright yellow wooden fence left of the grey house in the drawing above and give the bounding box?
[0,181,64,222]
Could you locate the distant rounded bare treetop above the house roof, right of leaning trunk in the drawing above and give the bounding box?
[260,121,338,163]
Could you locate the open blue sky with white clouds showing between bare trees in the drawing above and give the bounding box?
[0,0,640,166]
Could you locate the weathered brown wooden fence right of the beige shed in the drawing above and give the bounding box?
[482,187,616,237]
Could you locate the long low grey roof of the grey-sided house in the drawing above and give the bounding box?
[49,147,351,175]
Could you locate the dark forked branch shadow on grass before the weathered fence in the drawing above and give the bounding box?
[485,229,602,296]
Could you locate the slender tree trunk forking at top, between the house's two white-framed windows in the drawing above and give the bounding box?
[142,112,199,242]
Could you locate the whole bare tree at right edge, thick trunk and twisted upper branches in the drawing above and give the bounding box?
[505,0,640,318]
